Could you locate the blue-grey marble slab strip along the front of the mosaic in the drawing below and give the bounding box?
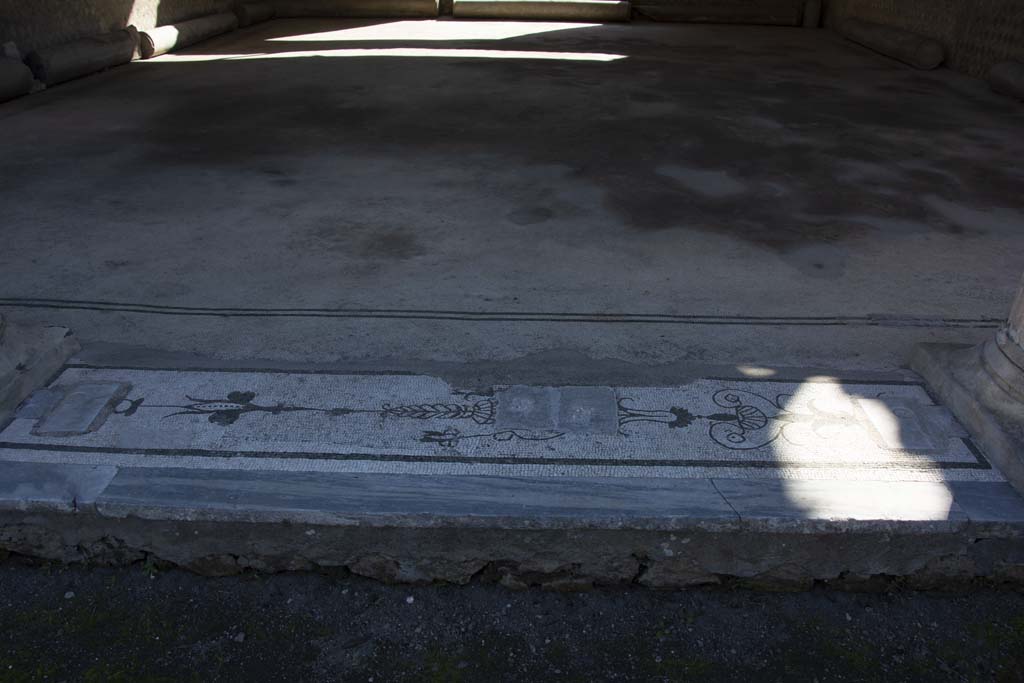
[6,458,1024,536]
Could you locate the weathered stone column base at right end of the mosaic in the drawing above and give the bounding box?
[910,340,1024,495]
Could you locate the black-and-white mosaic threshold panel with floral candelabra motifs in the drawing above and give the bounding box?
[0,367,1002,481]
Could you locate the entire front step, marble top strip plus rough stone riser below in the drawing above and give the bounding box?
[0,462,1024,589]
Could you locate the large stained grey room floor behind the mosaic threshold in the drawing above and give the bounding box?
[0,19,1024,370]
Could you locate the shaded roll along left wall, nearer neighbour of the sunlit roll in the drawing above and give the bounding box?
[27,26,138,85]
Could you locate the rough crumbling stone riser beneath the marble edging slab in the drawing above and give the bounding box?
[0,511,1024,589]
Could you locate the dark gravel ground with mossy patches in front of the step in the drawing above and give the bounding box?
[0,559,1024,683]
